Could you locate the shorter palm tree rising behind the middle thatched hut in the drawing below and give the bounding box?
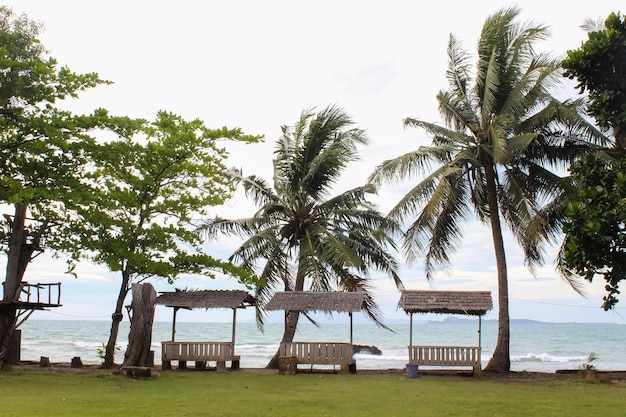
[201,106,402,367]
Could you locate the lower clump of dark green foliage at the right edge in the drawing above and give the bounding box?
[563,154,626,310]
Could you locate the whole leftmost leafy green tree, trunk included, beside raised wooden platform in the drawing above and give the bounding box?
[0,6,107,370]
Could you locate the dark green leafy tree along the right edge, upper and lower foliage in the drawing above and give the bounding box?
[560,13,626,310]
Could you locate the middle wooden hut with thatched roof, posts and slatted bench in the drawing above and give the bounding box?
[265,291,366,372]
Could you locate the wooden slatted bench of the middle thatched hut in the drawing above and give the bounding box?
[279,342,356,373]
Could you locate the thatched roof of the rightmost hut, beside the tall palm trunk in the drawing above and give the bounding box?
[398,290,493,316]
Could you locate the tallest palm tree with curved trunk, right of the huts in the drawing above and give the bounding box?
[370,8,599,372]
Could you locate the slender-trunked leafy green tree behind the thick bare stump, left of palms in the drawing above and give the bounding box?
[74,112,259,368]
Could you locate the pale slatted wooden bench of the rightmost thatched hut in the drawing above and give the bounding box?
[409,346,481,373]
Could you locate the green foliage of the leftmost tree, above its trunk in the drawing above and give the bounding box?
[0,7,107,245]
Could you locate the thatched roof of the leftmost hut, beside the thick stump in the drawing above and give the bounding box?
[155,290,254,309]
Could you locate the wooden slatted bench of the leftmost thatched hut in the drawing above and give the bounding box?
[161,342,240,371]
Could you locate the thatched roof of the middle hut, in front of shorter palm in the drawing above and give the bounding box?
[265,291,366,313]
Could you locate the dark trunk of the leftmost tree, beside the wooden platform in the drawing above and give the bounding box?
[0,203,30,371]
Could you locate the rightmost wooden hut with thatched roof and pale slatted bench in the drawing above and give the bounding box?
[398,290,493,371]
